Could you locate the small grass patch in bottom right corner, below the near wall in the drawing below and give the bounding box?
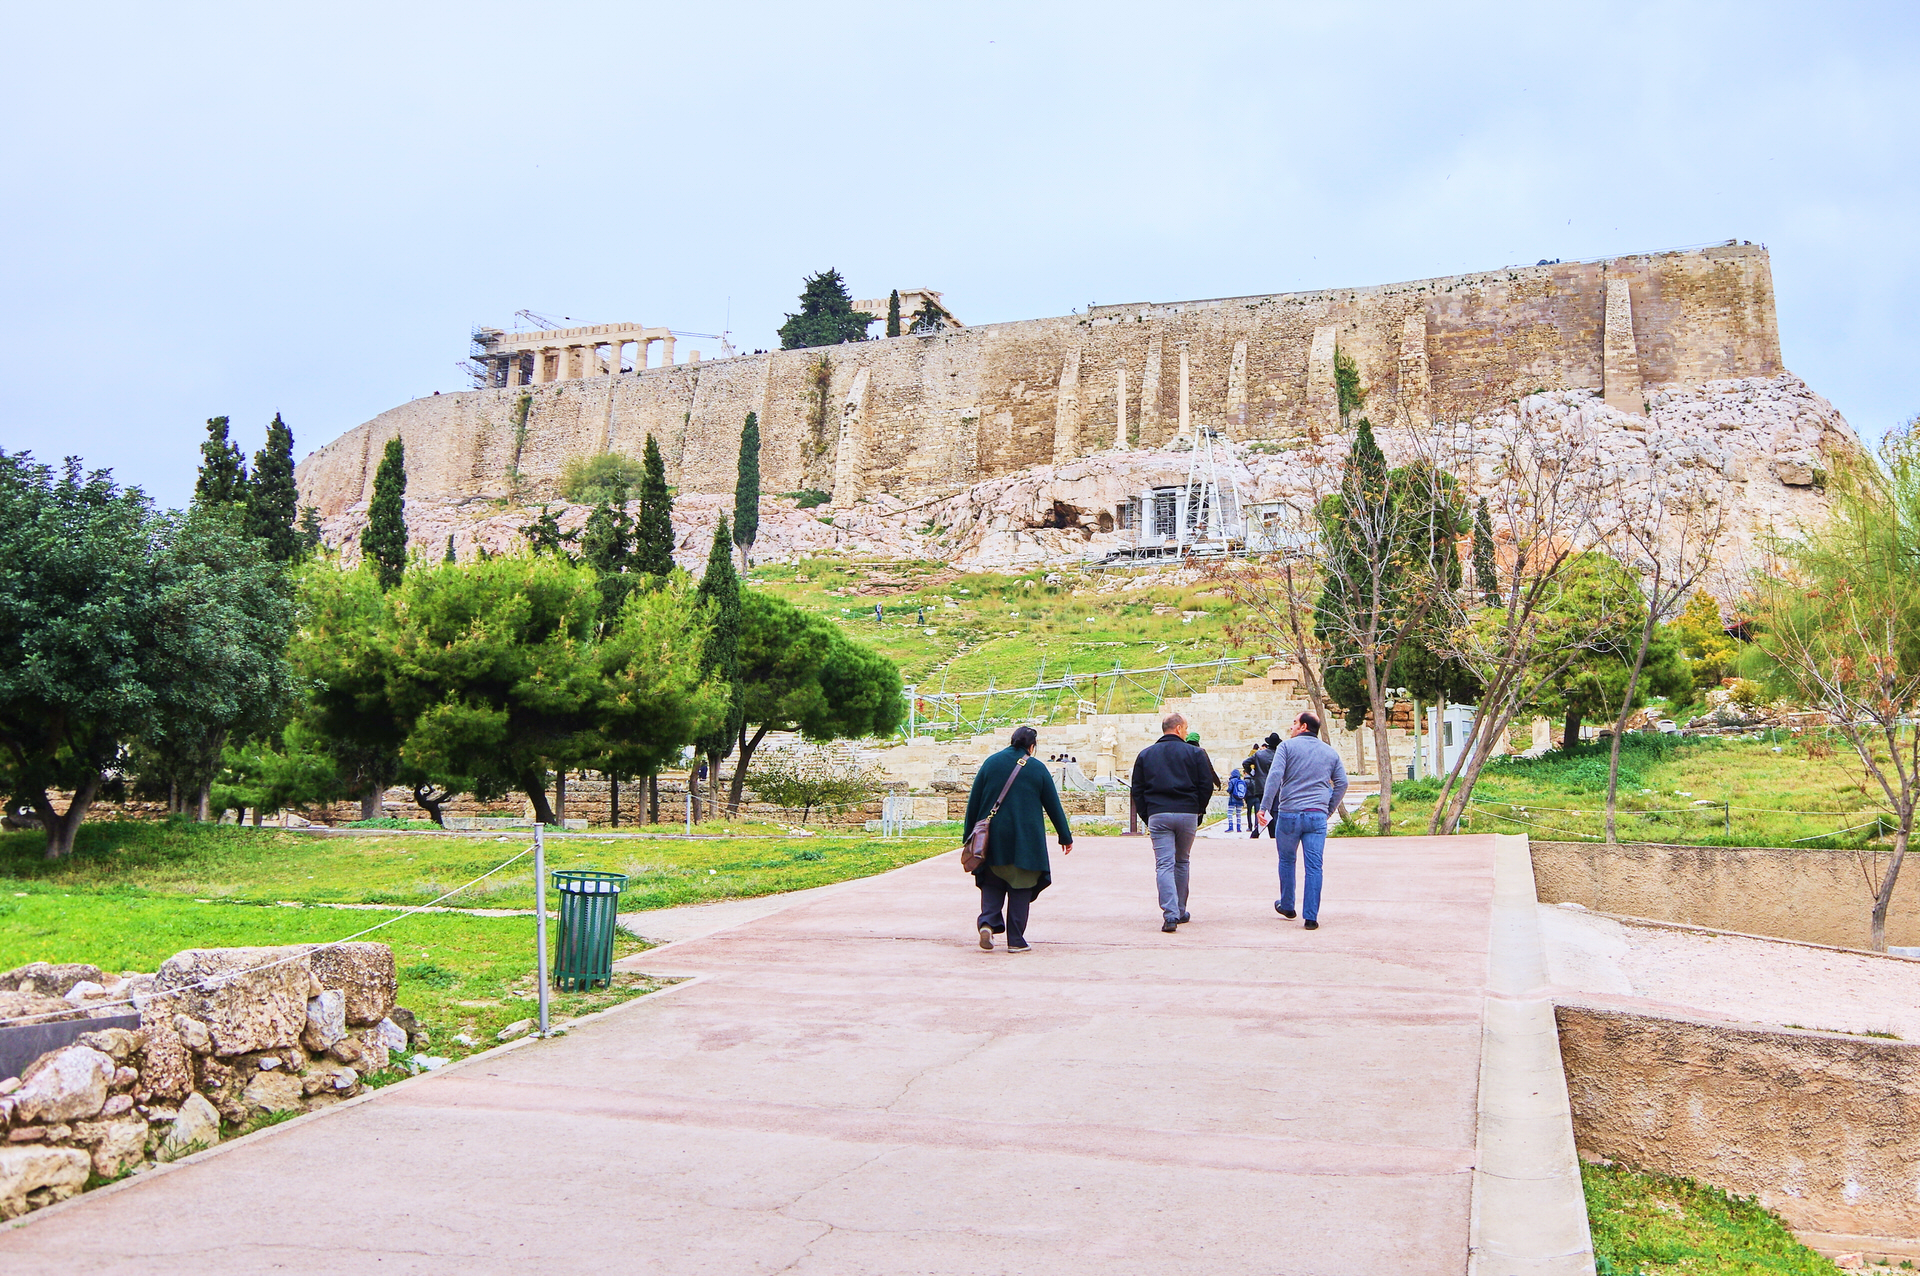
[1580,1165,1839,1276]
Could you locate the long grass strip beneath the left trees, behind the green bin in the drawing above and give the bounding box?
[0,821,958,911]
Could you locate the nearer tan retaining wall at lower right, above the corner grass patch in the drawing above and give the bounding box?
[1555,1005,1920,1253]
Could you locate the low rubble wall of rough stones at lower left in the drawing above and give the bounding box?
[0,942,428,1218]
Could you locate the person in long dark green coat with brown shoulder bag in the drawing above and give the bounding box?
[960,727,1073,952]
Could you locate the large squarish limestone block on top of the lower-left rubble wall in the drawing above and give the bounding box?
[154,948,311,1057]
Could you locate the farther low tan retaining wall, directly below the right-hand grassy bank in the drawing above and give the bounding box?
[1532,842,1920,948]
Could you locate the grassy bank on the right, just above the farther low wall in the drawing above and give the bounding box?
[1363,731,1885,848]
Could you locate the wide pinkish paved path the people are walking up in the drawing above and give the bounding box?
[0,837,1592,1276]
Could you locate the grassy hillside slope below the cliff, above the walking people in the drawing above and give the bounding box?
[751,556,1260,729]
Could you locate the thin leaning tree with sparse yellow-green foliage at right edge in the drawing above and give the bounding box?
[1755,422,1920,952]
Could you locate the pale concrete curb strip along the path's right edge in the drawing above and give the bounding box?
[1467,833,1594,1276]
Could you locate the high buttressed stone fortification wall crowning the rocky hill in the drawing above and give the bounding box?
[300,246,1782,516]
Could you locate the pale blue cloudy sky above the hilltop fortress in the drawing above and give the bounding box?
[0,0,1920,505]
